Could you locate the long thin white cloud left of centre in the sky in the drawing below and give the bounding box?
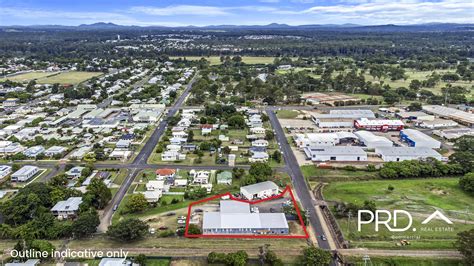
[130,5,229,16]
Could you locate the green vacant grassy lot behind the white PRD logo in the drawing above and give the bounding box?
[323,178,473,249]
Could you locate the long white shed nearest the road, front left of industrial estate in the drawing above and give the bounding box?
[304,146,367,162]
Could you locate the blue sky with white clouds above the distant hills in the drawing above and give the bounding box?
[0,0,474,26]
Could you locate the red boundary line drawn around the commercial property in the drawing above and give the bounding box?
[184,186,309,239]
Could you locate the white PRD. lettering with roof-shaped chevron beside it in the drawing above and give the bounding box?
[357,210,453,232]
